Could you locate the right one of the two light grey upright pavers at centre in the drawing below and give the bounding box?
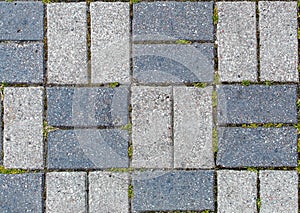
[173,87,214,168]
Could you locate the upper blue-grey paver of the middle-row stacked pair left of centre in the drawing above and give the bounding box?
[47,87,129,127]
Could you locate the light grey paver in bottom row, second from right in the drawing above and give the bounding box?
[217,170,257,213]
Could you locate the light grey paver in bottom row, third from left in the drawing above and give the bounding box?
[89,172,129,213]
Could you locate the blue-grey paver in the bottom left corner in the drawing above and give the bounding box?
[0,173,43,213]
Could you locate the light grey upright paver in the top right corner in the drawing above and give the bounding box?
[258,1,299,82]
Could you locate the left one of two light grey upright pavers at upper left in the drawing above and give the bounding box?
[47,2,88,84]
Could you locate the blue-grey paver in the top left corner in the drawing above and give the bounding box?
[0,1,44,41]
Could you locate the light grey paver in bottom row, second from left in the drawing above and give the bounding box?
[46,172,87,213]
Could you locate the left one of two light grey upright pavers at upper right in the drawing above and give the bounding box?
[217,2,257,82]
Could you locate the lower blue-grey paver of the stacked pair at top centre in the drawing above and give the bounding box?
[133,43,214,83]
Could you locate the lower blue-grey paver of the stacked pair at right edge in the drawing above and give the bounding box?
[217,127,298,168]
